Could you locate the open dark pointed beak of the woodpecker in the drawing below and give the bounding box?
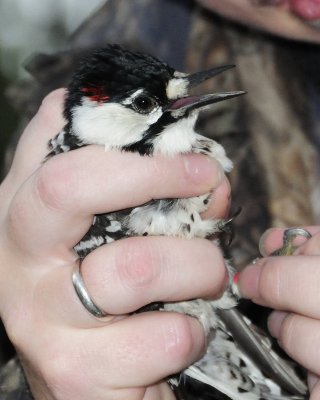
[166,65,246,115]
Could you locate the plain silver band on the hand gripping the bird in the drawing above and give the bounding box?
[72,259,108,318]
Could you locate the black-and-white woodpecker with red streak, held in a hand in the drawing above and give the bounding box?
[47,44,306,400]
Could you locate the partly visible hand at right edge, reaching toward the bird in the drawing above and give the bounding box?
[239,226,320,400]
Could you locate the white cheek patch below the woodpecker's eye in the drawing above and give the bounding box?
[72,98,162,148]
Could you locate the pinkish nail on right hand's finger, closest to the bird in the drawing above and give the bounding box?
[235,264,262,299]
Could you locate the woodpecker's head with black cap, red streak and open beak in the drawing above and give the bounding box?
[65,45,244,154]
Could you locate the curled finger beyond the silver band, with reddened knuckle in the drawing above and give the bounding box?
[81,237,227,314]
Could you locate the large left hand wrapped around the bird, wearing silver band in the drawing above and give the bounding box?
[0,90,230,400]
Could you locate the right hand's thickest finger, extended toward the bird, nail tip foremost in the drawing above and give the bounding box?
[238,256,320,318]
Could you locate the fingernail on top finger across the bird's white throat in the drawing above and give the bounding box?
[183,154,224,189]
